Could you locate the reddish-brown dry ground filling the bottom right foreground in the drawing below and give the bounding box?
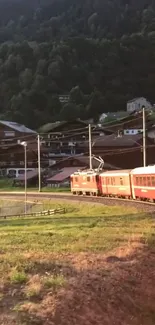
[0,238,155,325]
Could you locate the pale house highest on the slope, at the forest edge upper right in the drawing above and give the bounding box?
[127,97,152,113]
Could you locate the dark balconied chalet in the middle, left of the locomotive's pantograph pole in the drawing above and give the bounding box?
[38,119,112,161]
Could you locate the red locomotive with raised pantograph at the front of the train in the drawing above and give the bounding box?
[71,171,101,196]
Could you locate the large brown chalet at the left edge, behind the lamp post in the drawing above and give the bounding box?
[0,120,45,177]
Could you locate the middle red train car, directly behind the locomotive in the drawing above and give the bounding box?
[100,169,132,198]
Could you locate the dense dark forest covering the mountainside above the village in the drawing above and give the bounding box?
[0,0,155,128]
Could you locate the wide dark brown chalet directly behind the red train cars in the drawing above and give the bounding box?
[81,134,155,169]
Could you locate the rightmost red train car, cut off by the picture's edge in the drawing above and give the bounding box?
[131,166,155,202]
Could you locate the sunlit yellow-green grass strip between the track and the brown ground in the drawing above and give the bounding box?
[0,202,153,264]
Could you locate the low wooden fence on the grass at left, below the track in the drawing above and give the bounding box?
[0,208,66,219]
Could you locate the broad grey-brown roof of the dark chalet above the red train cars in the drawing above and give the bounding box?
[85,134,143,147]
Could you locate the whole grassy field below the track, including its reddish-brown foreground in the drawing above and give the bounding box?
[0,202,155,325]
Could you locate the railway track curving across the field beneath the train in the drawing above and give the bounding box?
[0,192,155,213]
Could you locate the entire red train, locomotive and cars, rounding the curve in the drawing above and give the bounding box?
[70,165,155,202]
